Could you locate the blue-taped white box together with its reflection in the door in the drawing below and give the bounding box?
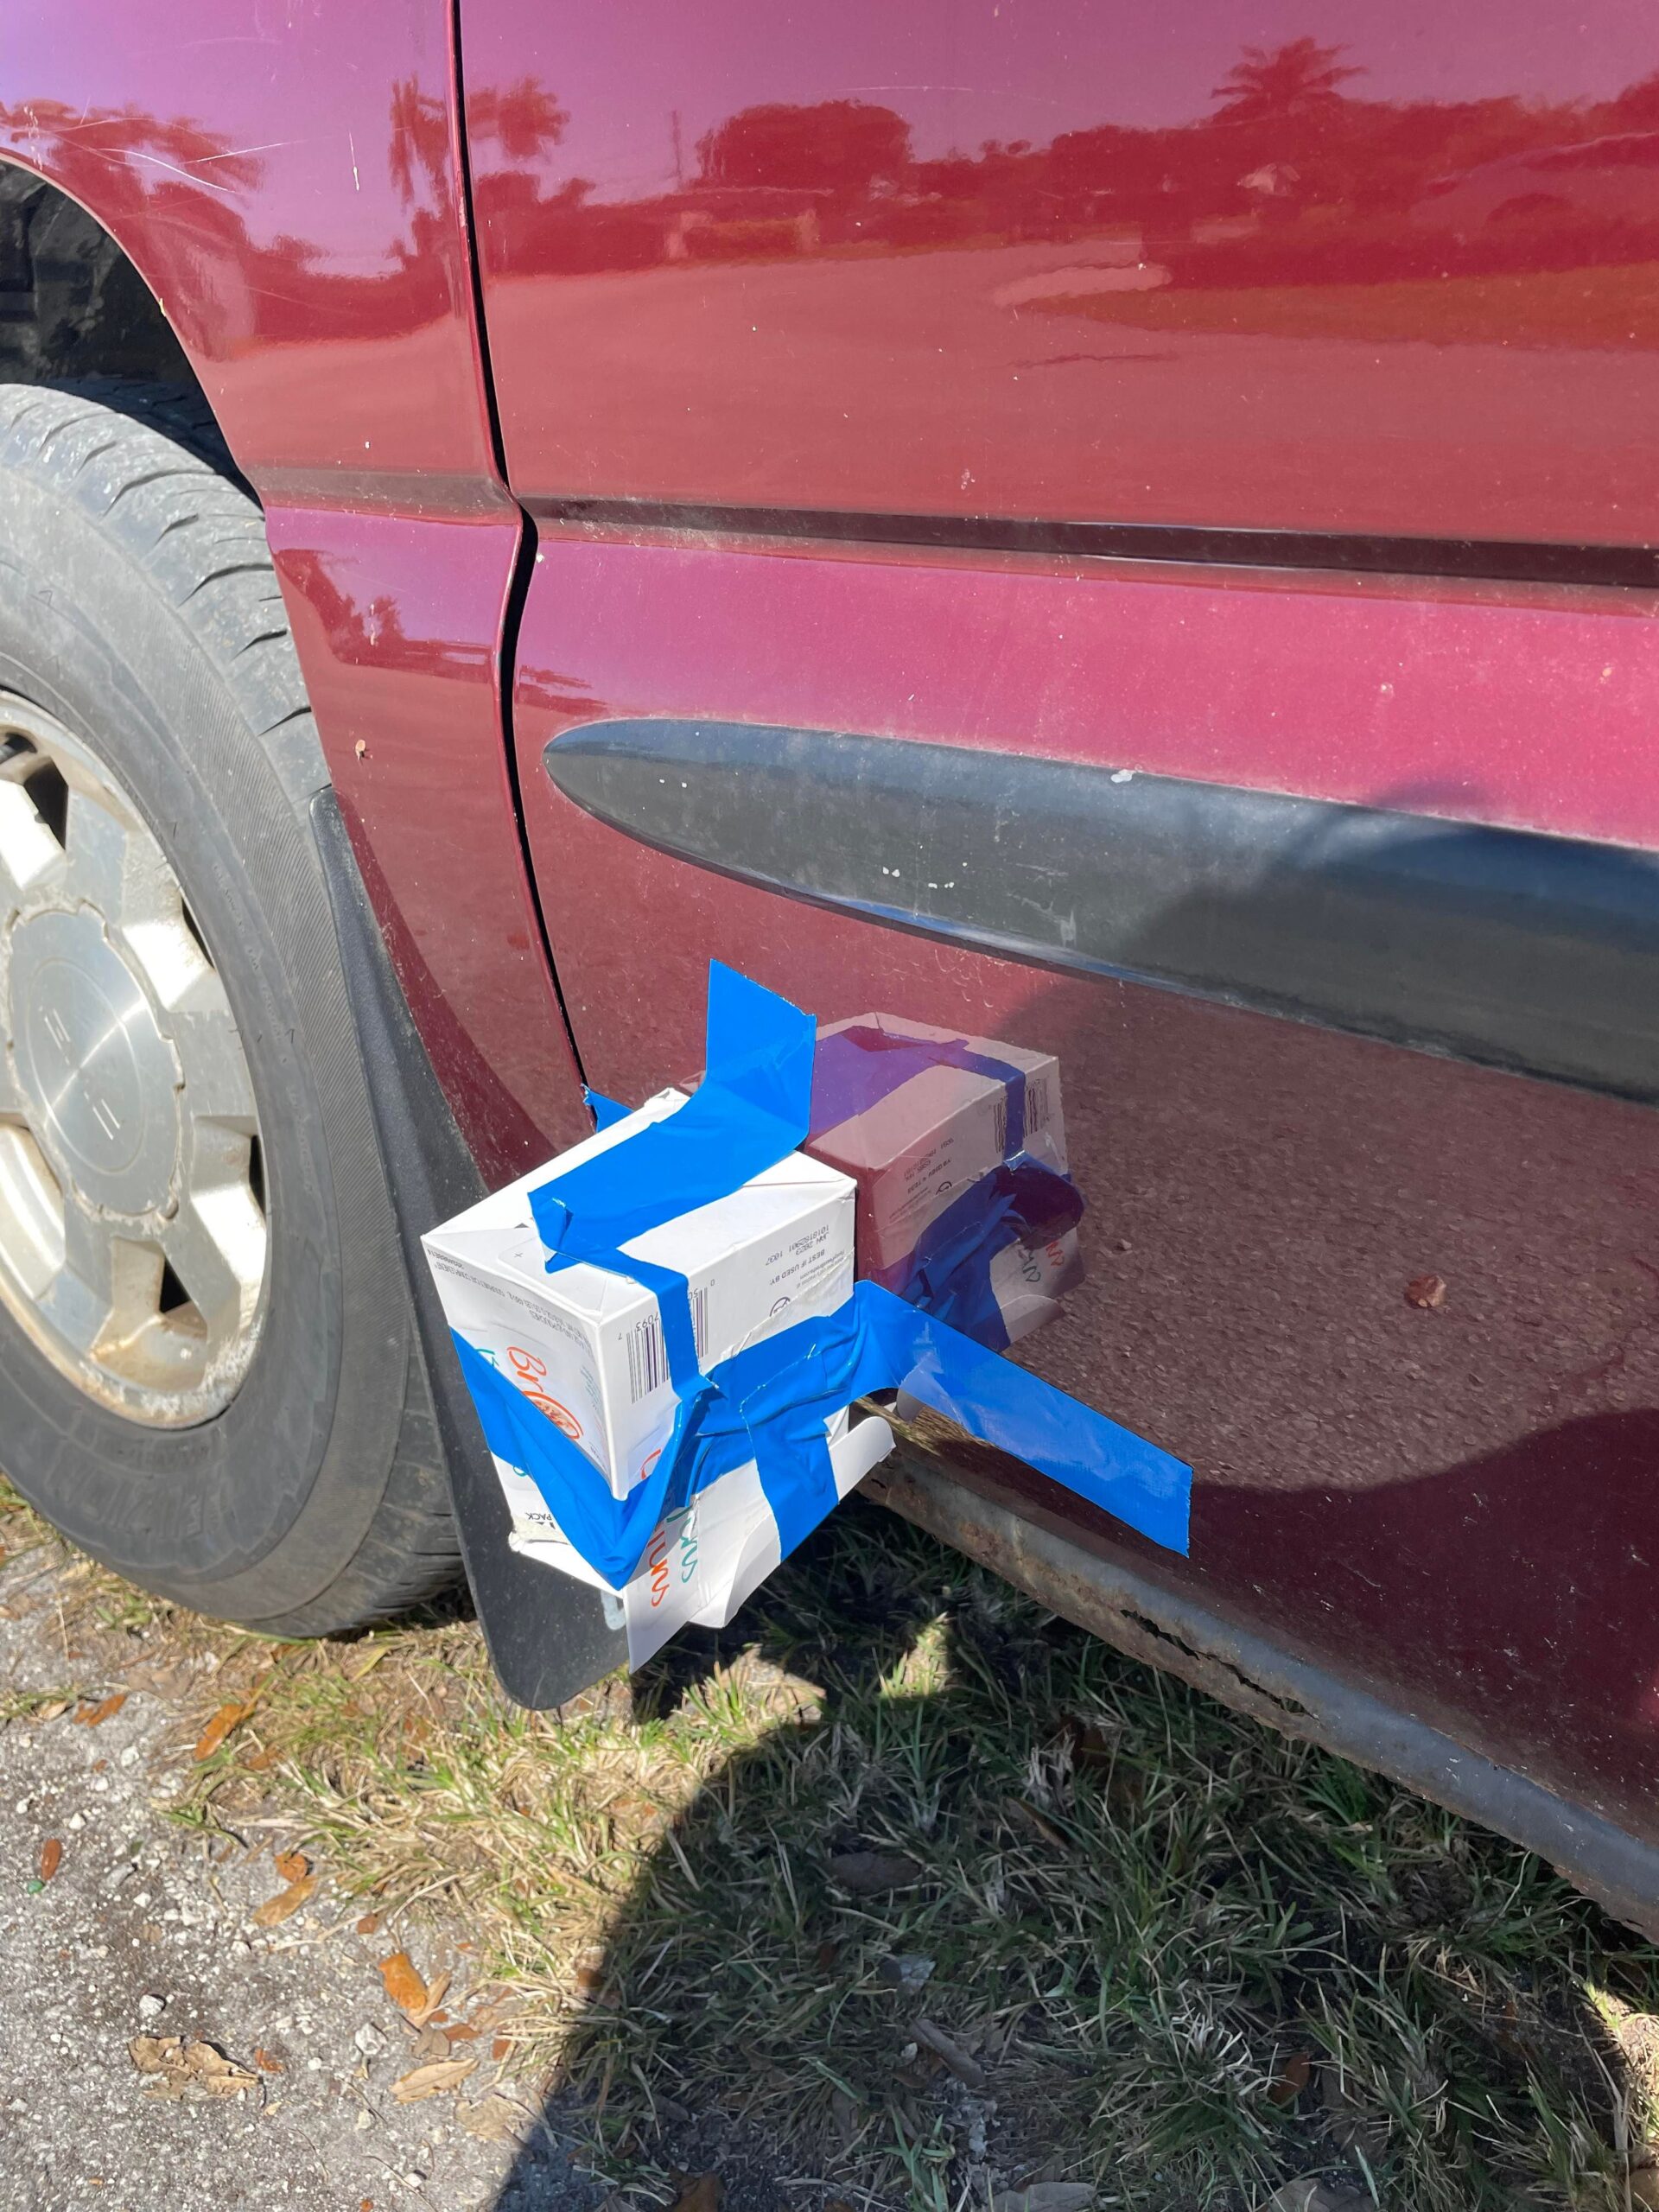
[425,963,1192,1666]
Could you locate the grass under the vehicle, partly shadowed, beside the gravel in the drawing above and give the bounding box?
[0,1500,1659,2212]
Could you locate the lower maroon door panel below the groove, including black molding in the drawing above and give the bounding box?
[515,529,1659,1822]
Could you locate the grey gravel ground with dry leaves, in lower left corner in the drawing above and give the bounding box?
[0,1551,600,2212]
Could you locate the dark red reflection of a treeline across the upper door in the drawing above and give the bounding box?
[435,35,1659,289]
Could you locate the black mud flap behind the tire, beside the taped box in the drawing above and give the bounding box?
[312,791,628,1710]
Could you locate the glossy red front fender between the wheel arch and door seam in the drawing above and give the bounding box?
[0,0,582,1177]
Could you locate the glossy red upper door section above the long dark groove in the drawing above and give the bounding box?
[462,0,1659,544]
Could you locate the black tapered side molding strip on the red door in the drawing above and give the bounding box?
[544,719,1659,1102]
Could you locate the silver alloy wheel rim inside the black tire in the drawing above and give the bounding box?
[0,695,268,1427]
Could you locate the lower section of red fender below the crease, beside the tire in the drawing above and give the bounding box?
[268,506,591,1181]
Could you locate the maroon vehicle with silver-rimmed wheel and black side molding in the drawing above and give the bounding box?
[0,0,1659,1929]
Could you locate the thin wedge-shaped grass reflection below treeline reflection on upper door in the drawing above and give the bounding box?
[1022,261,1659,349]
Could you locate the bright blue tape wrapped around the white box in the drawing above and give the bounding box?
[455,963,1192,1588]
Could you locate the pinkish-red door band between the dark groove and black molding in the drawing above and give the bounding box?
[518,531,1659,844]
